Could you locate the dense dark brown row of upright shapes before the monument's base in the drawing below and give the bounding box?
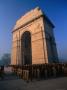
[8,63,67,81]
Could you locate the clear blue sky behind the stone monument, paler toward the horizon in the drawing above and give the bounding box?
[0,0,67,59]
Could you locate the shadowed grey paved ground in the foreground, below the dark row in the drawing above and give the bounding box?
[0,67,67,90]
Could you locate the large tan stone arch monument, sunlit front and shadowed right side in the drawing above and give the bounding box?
[11,7,58,65]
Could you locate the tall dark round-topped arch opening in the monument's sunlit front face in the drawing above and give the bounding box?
[21,31,32,65]
